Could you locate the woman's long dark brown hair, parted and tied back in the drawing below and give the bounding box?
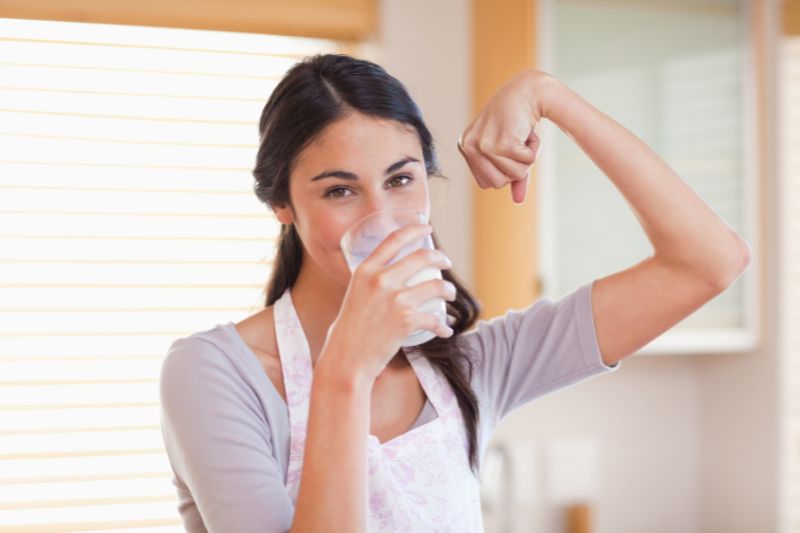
[253,54,481,473]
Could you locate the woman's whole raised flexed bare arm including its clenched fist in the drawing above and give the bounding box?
[460,70,750,365]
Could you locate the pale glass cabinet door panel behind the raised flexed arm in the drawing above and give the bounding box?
[538,0,758,353]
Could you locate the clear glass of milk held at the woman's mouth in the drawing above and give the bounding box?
[340,208,447,347]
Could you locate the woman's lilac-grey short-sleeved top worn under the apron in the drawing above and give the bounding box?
[160,280,620,533]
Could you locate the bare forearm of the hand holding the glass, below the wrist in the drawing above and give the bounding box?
[292,346,372,533]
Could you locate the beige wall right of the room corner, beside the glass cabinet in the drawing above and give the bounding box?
[698,0,780,533]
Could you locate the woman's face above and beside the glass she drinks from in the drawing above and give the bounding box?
[275,112,430,286]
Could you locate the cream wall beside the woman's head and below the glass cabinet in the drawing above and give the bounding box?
[377,0,777,533]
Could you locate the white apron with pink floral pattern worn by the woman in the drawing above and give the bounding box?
[274,288,483,533]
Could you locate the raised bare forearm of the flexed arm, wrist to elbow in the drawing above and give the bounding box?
[531,71,750,284]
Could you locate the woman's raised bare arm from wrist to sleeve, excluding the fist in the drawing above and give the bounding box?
[545,72,750,364]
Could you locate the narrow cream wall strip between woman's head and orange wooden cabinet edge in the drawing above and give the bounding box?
[376,0,472,283]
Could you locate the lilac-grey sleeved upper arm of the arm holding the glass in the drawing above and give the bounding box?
[160,338,294,533]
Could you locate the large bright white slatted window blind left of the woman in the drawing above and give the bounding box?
[0,19,339,532]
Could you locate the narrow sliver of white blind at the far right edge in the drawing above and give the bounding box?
[777,37,800,533]
